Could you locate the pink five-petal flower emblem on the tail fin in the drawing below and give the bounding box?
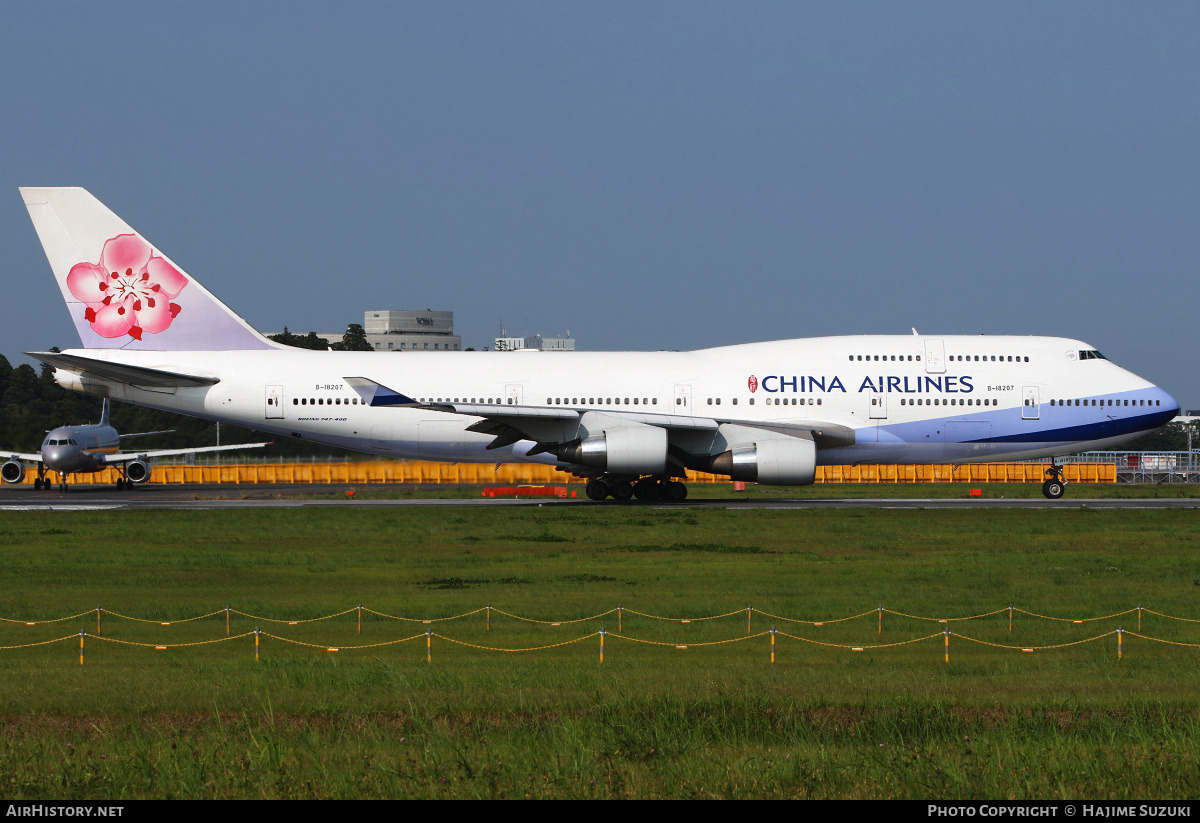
[67,234,187,340]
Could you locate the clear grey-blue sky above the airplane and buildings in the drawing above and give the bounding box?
[0,1,1200,408]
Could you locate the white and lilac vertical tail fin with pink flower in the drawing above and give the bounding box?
[20,187,278,352]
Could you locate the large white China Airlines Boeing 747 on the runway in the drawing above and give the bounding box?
[20,188,1178,500]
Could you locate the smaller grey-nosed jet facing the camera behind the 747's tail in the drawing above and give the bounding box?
[0,397,270,492]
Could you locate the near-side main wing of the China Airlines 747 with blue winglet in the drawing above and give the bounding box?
[346,377,854,453]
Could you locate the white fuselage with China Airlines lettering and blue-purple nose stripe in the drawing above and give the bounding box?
[56,336,1178,464]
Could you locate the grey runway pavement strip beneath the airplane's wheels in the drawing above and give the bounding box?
[0,483,1200,511]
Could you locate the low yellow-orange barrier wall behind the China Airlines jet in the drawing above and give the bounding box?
[25,461,1117,486]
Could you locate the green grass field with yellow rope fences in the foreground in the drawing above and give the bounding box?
[0,503,1200,799]
